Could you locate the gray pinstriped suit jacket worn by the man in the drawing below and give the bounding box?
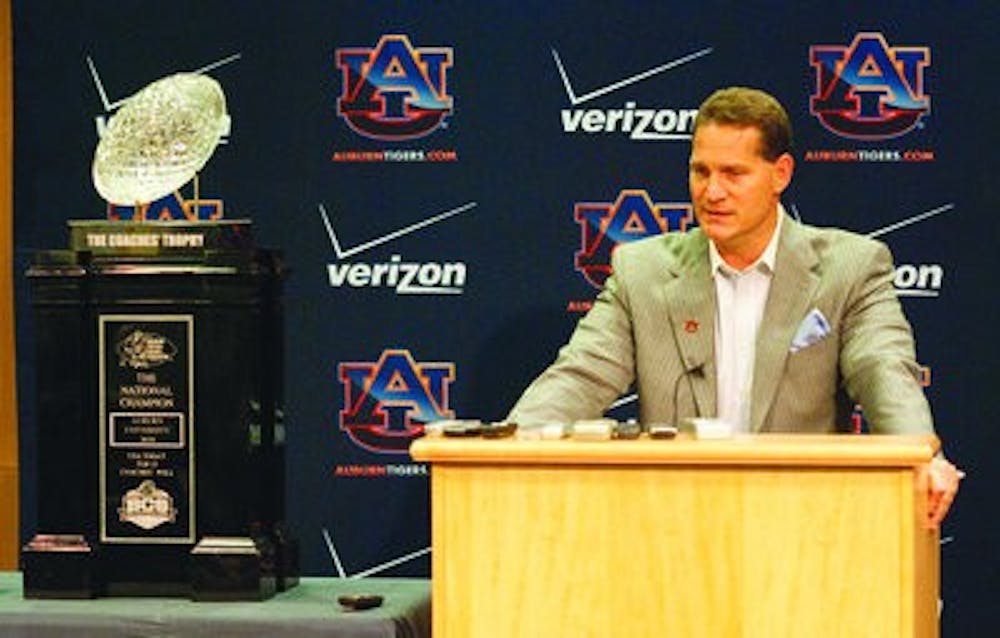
[508,217,933,433]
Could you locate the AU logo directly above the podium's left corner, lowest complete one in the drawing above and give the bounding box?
[338,350,455,454]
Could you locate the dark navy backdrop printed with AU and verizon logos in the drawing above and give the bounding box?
[13,0,1000,636]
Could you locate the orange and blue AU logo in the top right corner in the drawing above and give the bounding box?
[809,33,931,140]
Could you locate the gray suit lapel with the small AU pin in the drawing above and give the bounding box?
[665,231,715,416]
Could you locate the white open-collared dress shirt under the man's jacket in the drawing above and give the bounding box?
[709,209,785,432]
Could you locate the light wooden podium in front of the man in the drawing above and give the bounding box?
[411,435,939,638]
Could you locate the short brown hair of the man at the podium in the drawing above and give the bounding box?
[692,86,792,162]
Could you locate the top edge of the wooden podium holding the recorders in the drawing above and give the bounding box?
[410,433,939,467]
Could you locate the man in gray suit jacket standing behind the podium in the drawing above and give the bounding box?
[508,88,961,526]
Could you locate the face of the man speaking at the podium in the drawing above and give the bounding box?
[688,123,794,268]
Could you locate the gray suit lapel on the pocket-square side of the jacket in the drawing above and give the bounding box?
[750,217,819,432]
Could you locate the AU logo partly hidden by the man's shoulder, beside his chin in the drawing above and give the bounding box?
[573,189,693,289]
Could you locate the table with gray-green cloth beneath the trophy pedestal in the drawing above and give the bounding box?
[0,572,431,638]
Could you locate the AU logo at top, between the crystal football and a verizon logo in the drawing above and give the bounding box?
[336,35,452,140]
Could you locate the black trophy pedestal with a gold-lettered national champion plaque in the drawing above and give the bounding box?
[22,221,298,600]
